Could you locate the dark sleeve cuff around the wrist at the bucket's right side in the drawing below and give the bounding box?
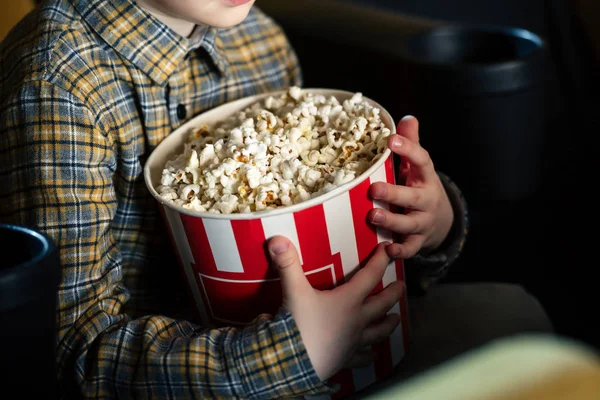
[405,172,469,295]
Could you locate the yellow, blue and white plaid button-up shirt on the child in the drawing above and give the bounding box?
[0,0,329,399]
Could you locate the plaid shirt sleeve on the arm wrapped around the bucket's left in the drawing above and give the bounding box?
[0,82,330,399]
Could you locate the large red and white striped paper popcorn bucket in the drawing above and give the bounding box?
[144,89,409,398]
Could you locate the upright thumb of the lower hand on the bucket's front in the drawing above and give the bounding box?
[268,236,312,298]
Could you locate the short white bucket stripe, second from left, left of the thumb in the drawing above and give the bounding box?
[202,218,244,273]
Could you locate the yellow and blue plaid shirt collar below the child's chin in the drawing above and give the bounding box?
[71,0,228,86]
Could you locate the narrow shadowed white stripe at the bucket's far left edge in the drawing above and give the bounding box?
[161,206,211,327]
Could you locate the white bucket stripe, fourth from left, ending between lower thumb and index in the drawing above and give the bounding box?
[323,192,360,277]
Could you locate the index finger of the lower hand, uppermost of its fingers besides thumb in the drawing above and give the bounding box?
[340,242,390,302]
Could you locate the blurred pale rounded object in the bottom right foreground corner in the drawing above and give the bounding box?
[365,335,600,400]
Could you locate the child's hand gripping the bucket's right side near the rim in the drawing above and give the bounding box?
[369,117,454,259]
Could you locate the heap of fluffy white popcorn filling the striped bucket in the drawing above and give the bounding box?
[157,87,391,214]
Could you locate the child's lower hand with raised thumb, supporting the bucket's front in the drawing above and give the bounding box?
[269,236,405,381]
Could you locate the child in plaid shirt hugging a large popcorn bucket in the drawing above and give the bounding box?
[0,0,548,398]
